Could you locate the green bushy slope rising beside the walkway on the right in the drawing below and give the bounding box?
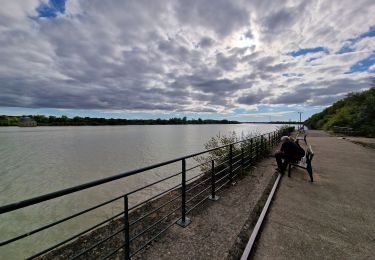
[305,85,375,137]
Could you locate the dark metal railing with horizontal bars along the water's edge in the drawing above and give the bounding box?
[0,129,291,259]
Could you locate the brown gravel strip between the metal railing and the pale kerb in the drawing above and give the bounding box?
[136,157,276,259]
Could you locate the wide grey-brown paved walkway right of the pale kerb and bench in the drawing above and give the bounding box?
[252,131,375,259]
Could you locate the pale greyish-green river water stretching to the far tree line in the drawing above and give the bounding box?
[0,124,279,259]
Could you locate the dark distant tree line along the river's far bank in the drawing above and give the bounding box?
[0,115,239,126]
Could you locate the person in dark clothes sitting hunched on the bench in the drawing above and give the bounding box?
[275,136,305,173]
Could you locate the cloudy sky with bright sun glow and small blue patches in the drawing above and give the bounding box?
[0,0,375,121]
